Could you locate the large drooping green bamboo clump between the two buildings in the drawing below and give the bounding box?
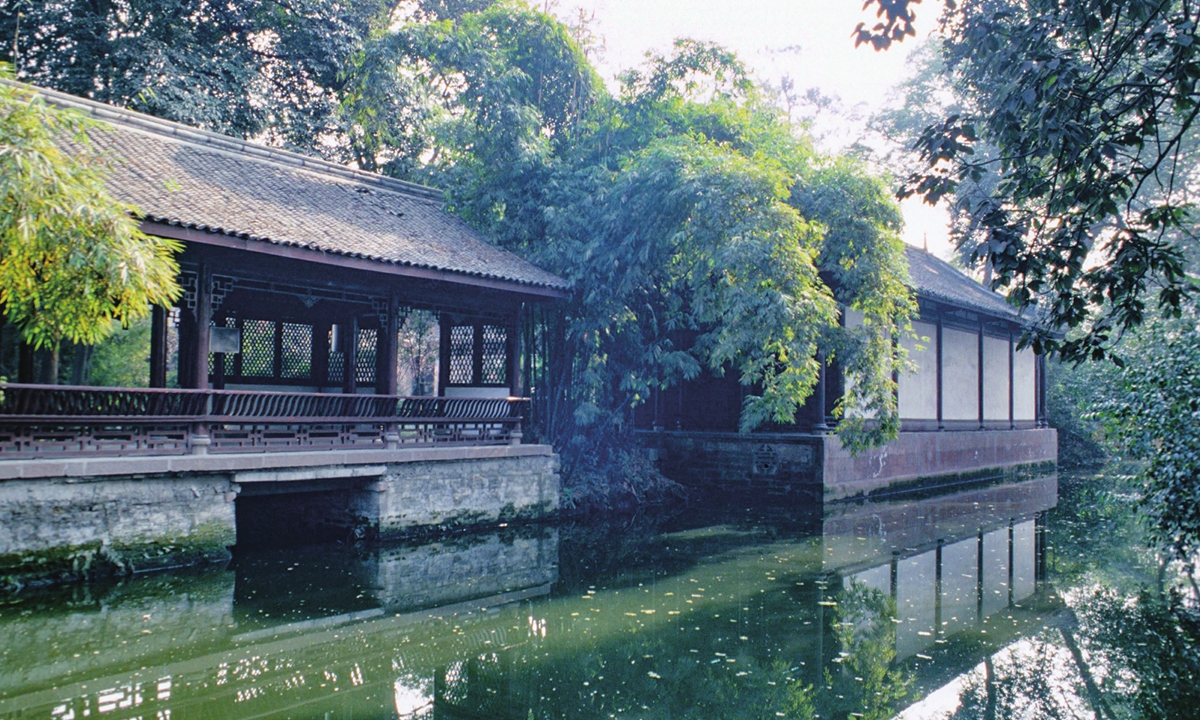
[379,11,913,453]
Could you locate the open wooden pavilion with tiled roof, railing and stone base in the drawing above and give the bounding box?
[0,80,565,585]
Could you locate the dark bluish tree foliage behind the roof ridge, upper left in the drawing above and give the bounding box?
[0,0,416,170]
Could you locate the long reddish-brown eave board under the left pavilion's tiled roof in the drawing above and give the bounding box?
[142,220,570,299]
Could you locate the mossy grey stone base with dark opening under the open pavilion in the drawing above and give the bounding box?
[0,445,560,588]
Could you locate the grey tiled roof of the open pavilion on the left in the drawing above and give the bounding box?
[21,81,566,289]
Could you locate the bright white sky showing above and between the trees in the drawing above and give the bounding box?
[541,0,950,257]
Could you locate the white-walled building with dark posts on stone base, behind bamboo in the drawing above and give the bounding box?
[637,247,1057,500]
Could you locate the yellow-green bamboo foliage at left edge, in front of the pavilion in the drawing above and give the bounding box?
[0,67,181,360]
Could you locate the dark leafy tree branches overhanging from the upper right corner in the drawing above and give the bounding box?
[858,0,1200,359]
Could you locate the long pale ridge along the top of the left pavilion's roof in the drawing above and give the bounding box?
[0,78,445,202]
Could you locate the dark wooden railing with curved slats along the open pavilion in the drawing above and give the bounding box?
[0,384,527,461]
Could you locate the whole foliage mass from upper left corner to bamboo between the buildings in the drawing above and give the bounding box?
[0,0,914,470]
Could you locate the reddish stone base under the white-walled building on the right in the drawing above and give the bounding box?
[640,428,1058,504]
